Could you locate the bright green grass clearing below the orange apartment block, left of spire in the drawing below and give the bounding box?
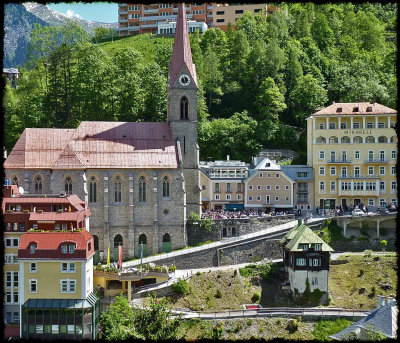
[98,34,174,62]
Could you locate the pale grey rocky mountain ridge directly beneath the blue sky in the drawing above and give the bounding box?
[23,2,118,34]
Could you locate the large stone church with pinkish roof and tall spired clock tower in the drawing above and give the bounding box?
[4,3,201,262]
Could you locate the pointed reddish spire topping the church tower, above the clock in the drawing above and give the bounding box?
[168,2,197,87]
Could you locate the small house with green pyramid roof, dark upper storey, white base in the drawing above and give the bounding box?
[280,219,333,301]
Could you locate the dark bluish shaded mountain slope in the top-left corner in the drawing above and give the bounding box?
[3,4,48,68]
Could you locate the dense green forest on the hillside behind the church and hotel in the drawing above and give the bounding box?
[3,3,397,163]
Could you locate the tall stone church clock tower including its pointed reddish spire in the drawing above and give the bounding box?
[167,3,201,216]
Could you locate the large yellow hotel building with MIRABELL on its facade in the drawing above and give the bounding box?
[307,102,397,209]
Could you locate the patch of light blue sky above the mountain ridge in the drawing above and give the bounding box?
[46,2,118,23]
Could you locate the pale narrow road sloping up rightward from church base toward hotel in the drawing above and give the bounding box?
[123,218,321,268]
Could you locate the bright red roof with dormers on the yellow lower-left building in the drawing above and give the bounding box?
[18,230,94,258]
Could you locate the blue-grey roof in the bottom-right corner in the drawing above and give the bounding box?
[329,301,398,341]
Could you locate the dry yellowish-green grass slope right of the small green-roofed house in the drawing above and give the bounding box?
[329,255,397,310]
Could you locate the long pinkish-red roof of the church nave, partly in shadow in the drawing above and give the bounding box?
[4,121,178,169]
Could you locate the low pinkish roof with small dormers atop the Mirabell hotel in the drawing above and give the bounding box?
[312,102,397,116]
